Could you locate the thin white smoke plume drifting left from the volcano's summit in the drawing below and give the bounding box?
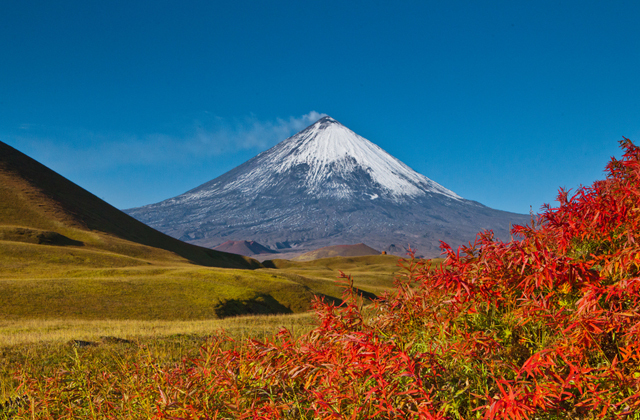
[2,111,326,171]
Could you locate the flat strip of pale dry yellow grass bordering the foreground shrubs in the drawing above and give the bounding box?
[0,312,316,403]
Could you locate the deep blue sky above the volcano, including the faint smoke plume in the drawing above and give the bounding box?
[0,0,640,213]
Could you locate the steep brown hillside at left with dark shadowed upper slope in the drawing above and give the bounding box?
[0,142,260,269]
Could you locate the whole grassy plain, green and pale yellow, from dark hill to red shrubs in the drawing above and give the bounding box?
[0,251,444,401]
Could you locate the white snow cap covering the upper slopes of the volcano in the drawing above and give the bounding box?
[212,116,461,200]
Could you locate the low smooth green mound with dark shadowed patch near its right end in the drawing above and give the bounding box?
[0,268,312,320]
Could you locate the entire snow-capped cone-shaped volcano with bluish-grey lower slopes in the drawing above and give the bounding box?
[126,117,529,256]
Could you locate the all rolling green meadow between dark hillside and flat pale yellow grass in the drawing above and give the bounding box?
[0,246,418,320]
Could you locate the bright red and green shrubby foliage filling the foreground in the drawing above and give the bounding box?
[5,139,640,419]
